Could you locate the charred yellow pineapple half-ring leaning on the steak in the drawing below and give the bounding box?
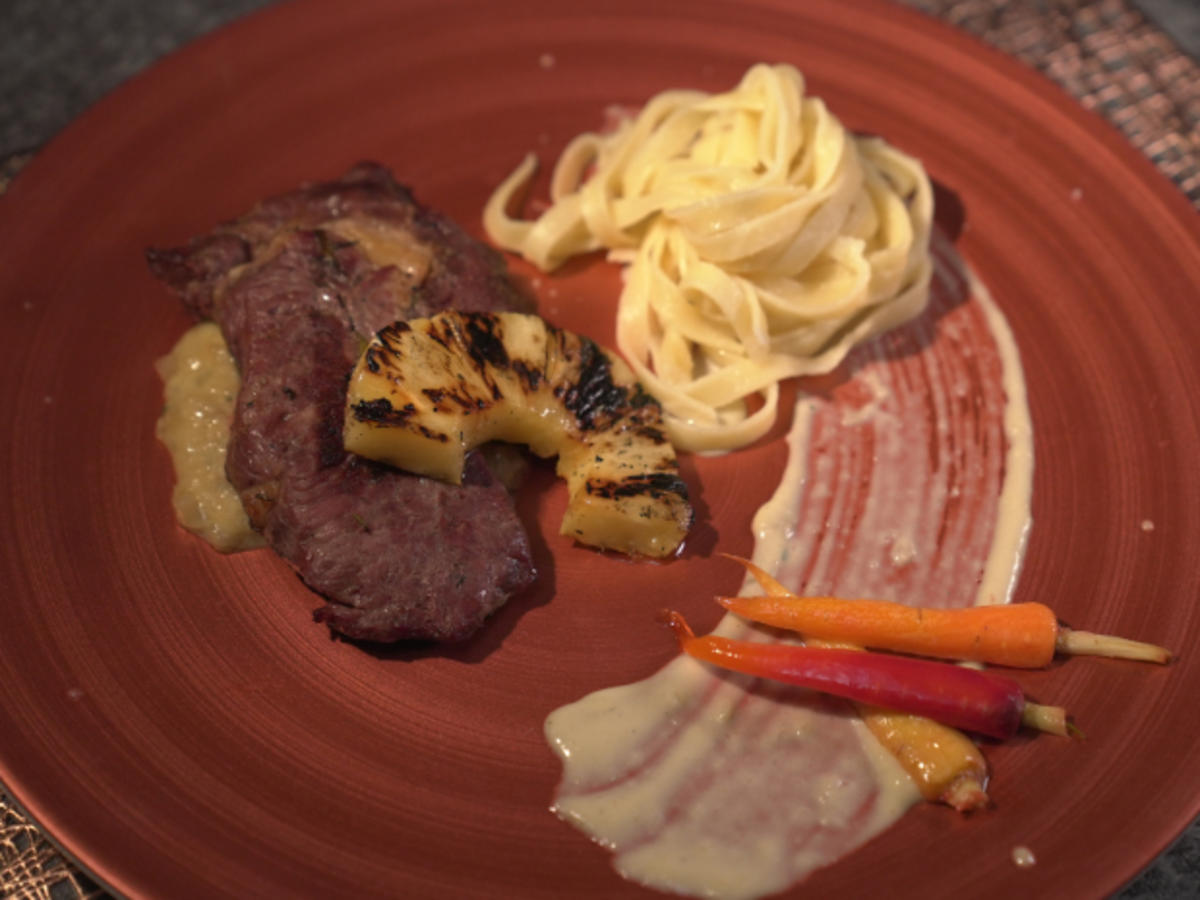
[343,312,692,557]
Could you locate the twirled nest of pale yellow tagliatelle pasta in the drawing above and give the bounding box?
[484,64,934,451]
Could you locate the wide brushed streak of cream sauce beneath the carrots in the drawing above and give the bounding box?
[545,232,1033,900]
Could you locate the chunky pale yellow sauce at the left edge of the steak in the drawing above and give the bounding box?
[155,322,264,553]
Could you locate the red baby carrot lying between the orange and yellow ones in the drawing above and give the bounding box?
[661,611,1067,738]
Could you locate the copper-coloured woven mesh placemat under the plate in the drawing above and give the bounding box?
[0,0,1200,900]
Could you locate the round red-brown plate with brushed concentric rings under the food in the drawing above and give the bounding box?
[0,0,1200,898]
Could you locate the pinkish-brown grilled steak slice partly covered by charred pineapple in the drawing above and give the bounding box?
[148,164,534,642]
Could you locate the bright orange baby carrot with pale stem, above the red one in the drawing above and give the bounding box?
[718,557,1170,668]
